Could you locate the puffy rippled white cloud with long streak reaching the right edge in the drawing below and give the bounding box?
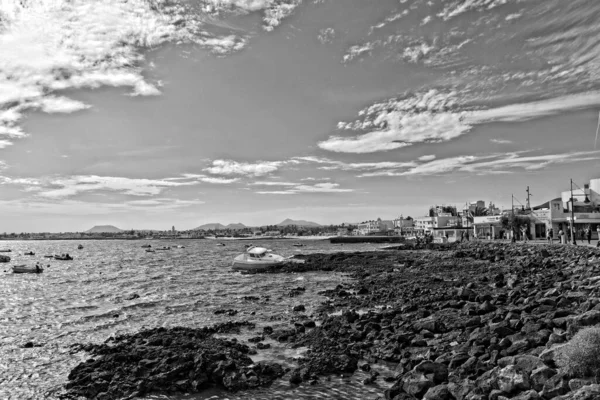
[318,90,600,153]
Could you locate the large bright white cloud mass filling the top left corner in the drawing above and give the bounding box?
[0,0,264,147]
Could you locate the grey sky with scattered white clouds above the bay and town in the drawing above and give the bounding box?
[0,0,600,232]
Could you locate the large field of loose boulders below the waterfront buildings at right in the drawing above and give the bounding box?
[276,243,600,400]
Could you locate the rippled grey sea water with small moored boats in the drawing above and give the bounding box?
[0,240,392,400]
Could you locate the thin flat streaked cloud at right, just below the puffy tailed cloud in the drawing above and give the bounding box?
[359,151,600,177]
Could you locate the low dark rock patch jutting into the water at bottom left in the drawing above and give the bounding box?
[62,322,285,400]
